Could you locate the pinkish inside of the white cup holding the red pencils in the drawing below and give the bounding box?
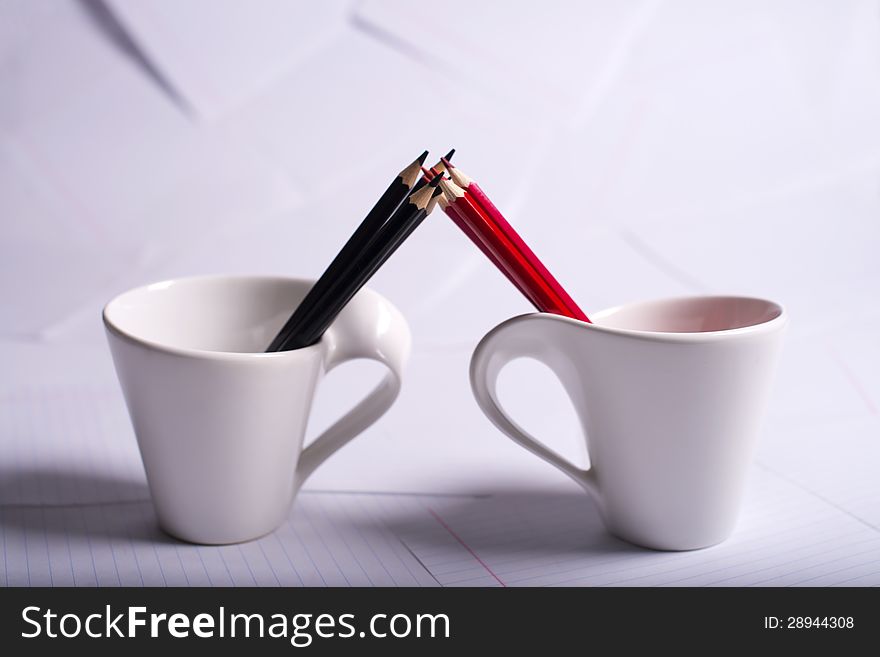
[590,297,782,333]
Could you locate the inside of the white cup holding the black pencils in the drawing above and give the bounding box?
[104,276,311,353]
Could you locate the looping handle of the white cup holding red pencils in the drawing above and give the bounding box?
[470,314,598,499]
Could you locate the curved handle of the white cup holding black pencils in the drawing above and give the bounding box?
[296,290,412,489]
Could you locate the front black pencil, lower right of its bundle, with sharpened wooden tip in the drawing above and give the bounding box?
[282,176,442,350]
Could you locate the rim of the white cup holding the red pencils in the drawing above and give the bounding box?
[531,294,788,343]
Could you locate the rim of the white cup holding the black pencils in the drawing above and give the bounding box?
[101,274,360,361]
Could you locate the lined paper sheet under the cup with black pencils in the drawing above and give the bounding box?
[0,493,446,586]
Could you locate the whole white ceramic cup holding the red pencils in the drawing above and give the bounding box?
[471,297,787,550]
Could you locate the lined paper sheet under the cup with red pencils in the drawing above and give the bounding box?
[400,468,880,586]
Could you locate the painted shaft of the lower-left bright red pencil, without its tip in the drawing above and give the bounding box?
[448,196,571,316]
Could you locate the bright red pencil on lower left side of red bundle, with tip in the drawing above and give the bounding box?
[440,180,580,319]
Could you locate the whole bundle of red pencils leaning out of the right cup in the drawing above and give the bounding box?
[425,158,590,322]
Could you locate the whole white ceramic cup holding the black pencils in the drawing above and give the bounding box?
[104,276,411,544]
